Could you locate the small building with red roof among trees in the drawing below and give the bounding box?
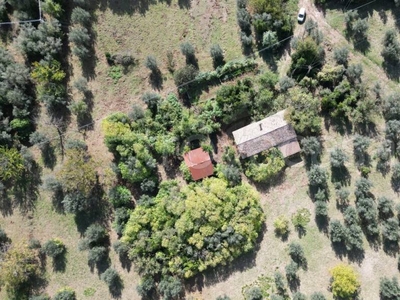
[183,148,214,180]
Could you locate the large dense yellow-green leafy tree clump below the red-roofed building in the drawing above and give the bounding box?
[122,178,264,278]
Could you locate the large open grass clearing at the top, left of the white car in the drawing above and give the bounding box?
[90,0,242,118]
